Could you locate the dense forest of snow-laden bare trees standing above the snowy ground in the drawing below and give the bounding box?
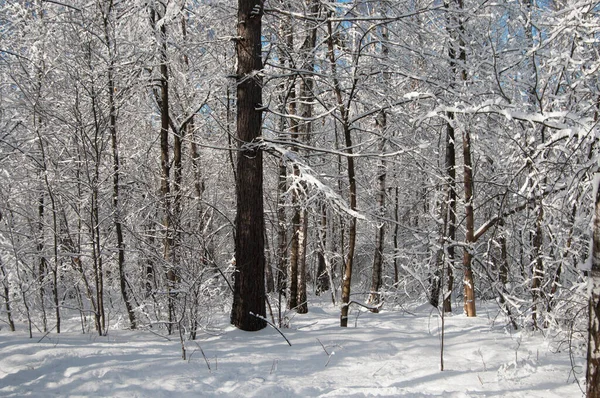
[0,0,600,397]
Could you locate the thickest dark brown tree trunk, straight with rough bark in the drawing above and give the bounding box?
[231,0,267,331]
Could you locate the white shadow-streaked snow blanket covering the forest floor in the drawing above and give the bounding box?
[0,304,583,398]
